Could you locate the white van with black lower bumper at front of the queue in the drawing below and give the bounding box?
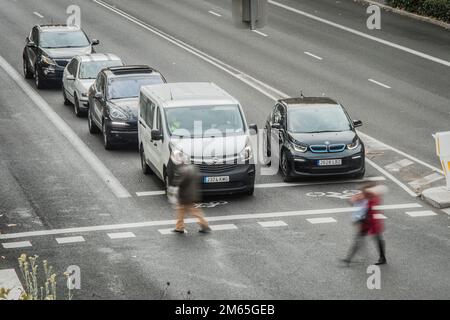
[138,82,257,195]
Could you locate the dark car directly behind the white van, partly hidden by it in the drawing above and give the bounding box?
[88,65,166,149]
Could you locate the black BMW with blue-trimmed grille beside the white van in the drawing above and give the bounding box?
[263,97,365,181]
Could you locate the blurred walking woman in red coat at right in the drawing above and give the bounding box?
[342,184,387,265]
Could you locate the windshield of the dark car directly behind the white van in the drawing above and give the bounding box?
[108,74,164,99]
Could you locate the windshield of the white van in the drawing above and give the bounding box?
[165,105,245,137]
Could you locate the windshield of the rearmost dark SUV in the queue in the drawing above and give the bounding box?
[39,30,90,48]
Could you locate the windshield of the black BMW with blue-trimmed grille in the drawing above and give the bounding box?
[287,104,351,133]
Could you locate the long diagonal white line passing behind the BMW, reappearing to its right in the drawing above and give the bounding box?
[94,0,444,185]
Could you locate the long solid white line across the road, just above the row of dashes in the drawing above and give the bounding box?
[0,202,422,240]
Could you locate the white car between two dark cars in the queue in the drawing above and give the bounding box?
[62,53,123,117]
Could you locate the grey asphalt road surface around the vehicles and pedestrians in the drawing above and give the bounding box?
[0,0,450,299]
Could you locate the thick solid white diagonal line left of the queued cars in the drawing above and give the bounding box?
[0,56,131,198]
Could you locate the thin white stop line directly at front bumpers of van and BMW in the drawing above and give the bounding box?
[136,176,386,197]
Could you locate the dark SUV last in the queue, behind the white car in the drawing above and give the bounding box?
[23,24,99,89]
